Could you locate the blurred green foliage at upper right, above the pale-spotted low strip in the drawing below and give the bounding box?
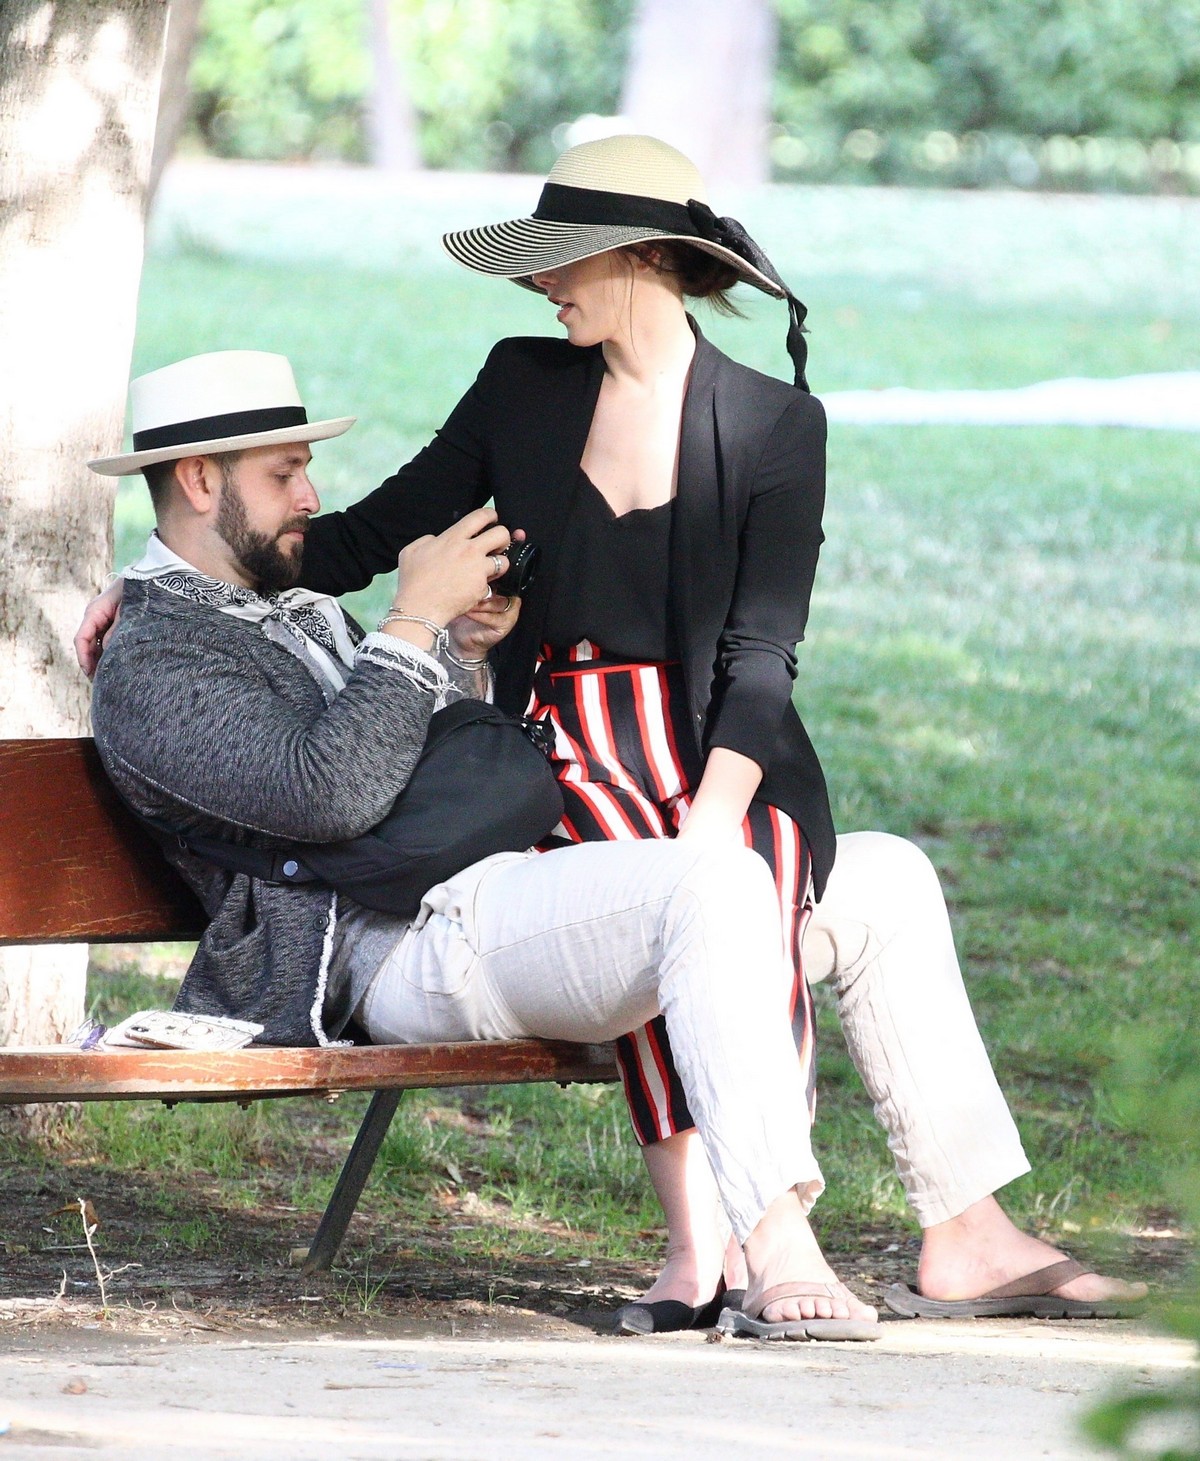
[779,0,1200,140]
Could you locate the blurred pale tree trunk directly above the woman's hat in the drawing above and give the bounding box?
[621,0,778,184]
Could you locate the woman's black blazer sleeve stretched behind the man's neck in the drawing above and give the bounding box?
[300,340,504,595]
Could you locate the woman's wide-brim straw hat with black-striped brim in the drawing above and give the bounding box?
[441,134,786,298]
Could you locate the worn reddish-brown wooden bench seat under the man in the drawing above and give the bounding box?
[0,1040,617,1106]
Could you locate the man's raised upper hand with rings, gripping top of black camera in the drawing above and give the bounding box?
[387,507,512,638]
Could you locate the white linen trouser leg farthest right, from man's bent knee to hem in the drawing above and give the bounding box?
[802,831,1029,1227]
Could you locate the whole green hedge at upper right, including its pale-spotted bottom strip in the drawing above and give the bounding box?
[772,0,1200,191]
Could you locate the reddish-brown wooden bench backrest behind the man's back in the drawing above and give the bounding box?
[0,739,206,944]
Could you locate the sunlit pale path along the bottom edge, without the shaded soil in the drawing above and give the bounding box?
[0,1300,1194,1461]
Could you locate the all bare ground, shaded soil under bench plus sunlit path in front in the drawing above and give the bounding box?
[0,1163,1193,1461]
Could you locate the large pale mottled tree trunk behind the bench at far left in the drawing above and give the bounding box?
[0,0,167,1139]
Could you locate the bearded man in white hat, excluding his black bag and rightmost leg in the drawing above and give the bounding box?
[92,352,877,1338]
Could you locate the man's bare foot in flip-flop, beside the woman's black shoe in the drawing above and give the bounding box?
[744,1189,878,1324]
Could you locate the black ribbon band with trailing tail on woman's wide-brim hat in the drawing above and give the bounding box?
[533,183,808,390]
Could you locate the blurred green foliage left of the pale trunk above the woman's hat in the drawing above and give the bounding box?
[184,0,633,171]
